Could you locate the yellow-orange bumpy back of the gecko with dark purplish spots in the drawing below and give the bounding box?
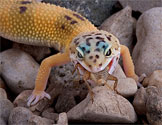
[0,0,97,50]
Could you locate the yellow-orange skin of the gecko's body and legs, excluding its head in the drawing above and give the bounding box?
[0,0,137,106]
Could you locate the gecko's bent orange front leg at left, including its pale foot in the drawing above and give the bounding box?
[27,51,70,106]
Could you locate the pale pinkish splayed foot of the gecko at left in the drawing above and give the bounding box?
[27,91,51,107]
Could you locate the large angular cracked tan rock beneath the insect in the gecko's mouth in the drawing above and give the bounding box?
[67,86,137,123]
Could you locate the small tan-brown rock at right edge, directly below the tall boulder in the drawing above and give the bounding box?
[142,70,162,88]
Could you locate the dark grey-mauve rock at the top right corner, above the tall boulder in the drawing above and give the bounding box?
[119,0,162,12]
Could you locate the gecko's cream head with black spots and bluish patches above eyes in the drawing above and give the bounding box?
[70,31,120,73]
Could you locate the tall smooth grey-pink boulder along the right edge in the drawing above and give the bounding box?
[133,7,162,76]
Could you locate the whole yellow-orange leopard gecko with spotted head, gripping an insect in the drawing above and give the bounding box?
[0,0,137,106]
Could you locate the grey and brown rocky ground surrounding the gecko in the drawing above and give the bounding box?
[0,0,162,125]
